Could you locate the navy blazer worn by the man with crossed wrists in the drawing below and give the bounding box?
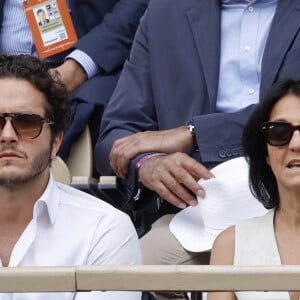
[95,0,300,202]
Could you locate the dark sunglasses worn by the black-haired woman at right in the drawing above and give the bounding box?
[260,122,300,146]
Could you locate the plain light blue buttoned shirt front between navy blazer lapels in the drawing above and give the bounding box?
[217,0,279,112]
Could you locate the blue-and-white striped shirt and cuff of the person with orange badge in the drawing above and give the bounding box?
[0,0,99,78]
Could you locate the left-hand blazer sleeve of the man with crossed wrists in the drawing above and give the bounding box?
[94,8,157,201]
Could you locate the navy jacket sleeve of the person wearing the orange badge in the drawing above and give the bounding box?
[74,0,149,73]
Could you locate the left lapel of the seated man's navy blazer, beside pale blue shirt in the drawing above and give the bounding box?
[187,0,221,111]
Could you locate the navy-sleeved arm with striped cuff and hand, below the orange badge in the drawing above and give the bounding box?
[55,0,149,93]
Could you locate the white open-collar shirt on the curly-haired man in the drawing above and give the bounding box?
[0,175,141,300]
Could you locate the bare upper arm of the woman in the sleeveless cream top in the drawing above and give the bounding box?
[207,227,237,300]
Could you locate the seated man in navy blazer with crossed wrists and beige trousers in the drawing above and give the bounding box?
[95,0,300,299]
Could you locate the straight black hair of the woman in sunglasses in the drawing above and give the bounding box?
[242,79,300,208]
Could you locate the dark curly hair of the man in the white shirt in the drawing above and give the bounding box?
[0,54,71,138]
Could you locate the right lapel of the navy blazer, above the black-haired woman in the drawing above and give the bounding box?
[260,0,300,96]
